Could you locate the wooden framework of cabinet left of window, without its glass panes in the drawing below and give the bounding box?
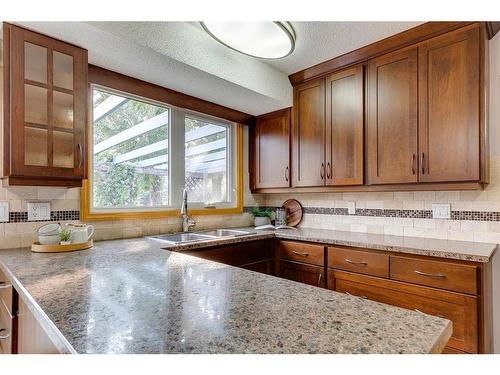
[1,23,87,187]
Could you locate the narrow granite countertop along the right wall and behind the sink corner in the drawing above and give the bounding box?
[162,227,498,262]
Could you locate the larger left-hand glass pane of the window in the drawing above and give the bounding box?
[93,89,170,209]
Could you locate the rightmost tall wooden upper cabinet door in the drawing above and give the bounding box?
[419,28,480,182]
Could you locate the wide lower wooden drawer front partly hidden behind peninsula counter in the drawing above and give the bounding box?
[328,270,478,353]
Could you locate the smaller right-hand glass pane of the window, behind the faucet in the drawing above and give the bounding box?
[185,116,229,204]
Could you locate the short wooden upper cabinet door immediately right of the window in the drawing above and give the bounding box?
[251,108,291,189]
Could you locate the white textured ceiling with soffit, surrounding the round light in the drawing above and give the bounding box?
[15,22,418,115]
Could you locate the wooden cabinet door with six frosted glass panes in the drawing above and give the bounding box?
[8,25,87,179]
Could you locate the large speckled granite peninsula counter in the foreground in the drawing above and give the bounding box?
[0,238,452,353]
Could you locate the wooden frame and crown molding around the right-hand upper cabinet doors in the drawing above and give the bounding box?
[251,22,491,193]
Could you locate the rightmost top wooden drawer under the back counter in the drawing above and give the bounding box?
[391,255,477,294]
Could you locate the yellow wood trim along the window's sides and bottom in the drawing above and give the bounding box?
[80,120,244,221]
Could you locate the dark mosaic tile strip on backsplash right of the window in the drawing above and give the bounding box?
[244,206,500,221]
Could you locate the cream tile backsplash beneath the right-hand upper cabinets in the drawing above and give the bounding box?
[259,157,500,247]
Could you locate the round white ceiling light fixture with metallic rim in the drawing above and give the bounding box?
[200,21,295,59]
